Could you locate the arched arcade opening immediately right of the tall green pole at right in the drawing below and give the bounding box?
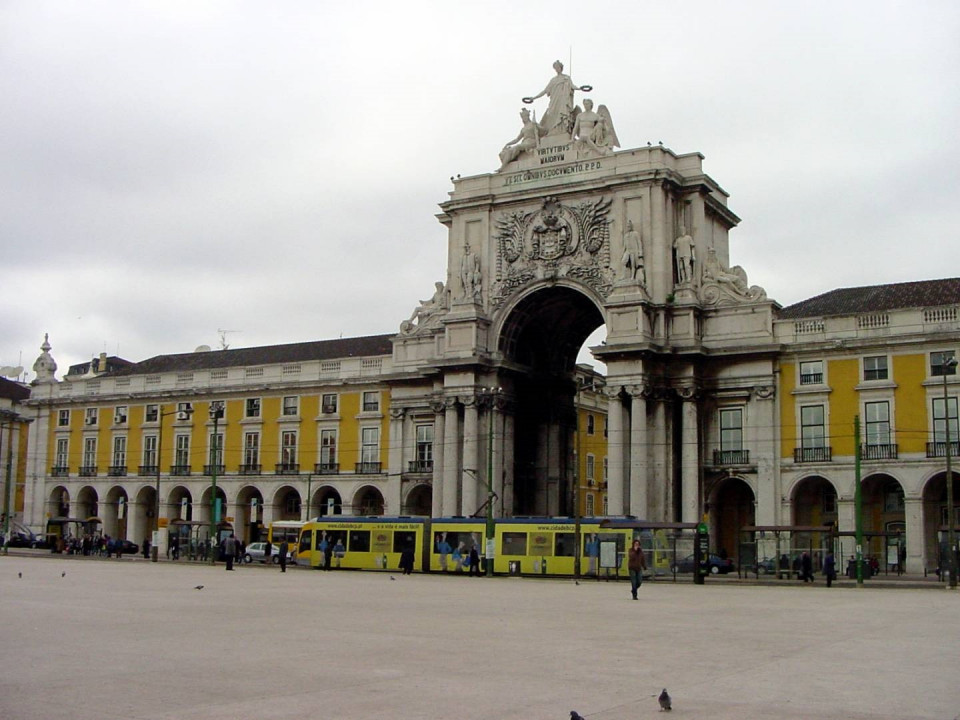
[860,473,907,571]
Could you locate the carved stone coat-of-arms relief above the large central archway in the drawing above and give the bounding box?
[491,197,614,308]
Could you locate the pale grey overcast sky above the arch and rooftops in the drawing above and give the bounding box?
[0,0,960,379]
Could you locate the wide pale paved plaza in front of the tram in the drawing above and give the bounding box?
[0,555,960,720]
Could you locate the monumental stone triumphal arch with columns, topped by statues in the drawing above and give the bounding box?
[391,62,779,522]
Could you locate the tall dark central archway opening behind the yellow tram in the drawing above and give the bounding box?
[498,284,606,517]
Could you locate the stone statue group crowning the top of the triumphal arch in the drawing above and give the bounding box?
[500,60,620,171]
